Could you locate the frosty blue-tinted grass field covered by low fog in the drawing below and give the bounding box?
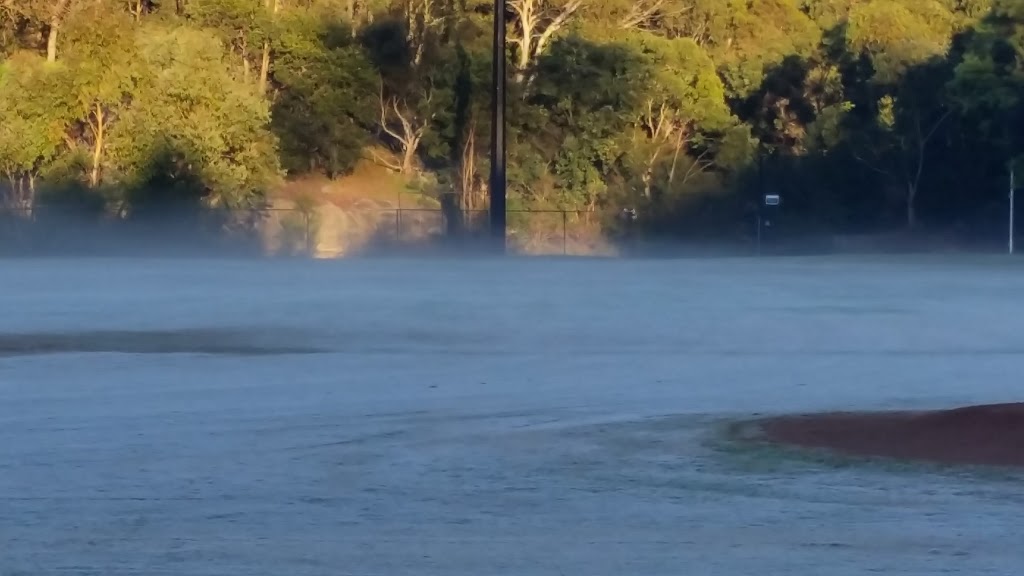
[0,257,1024,576]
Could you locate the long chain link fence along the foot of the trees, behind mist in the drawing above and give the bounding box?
[0,205,612,254]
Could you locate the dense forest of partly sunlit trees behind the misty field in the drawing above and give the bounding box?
[0,0,1024,243]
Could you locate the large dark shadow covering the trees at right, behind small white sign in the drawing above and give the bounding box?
[720,4,1024,249]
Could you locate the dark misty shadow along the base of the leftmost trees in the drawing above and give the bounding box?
[0,135,265,257]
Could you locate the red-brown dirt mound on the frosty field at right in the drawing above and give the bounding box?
[760,403,1024,466]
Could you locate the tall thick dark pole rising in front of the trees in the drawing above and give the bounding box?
[489,0,507,253]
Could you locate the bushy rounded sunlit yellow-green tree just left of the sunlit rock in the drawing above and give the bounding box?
[111,28,280,206]
